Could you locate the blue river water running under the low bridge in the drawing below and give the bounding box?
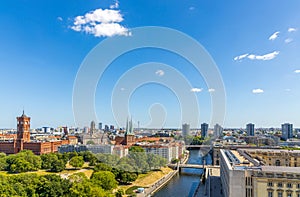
[154,150,212,197]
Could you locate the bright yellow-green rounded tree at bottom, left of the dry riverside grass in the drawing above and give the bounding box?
[91,171,118,190]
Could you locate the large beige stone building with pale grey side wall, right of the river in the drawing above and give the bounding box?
[220,149,300,197]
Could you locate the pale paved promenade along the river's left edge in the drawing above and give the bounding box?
[137,154,189,197]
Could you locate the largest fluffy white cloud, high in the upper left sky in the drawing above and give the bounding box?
[71,7,131,37]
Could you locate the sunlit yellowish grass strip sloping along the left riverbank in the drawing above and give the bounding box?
[118,167,173,191]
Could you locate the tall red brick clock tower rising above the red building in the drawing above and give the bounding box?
[15,111,30,153]
